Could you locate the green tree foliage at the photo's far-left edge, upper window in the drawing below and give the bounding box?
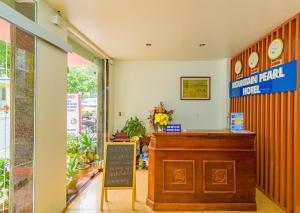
[0,40,11,77]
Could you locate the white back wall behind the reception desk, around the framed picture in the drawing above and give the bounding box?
[111,59,229,131]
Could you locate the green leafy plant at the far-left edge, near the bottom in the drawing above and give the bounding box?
[0,158,10,201]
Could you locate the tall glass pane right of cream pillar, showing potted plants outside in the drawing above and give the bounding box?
[67,53,98,200]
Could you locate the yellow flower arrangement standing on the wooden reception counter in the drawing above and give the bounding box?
[148,101,174,132]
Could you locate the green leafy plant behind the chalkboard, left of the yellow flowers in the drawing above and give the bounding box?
[123,117,146,138]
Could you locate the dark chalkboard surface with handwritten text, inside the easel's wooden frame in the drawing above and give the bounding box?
[104,143,135,187]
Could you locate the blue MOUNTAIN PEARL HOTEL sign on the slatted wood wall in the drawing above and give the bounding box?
[229,61,297,98]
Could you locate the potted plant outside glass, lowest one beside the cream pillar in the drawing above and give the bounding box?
[67,156,79,190]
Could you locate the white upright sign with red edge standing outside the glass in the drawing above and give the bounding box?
[67,94,81,135]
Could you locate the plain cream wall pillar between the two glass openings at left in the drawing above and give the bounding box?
[34,1,67,213]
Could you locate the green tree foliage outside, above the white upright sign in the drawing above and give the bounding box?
[67,65,97,94]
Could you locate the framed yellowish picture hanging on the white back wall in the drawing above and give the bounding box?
[180,77,211,100]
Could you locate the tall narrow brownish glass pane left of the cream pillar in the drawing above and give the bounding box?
[12,28,35,212]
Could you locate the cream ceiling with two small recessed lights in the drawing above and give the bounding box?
[48,0,300,60]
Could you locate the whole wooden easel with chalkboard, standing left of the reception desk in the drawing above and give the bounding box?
[100,142,136,211]
